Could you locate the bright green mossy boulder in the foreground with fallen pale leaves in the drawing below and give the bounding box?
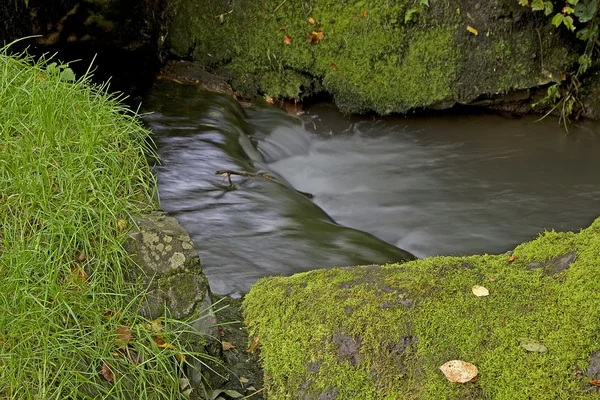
[244,219,600,400]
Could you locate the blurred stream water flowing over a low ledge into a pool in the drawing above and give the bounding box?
[146,83,600,295]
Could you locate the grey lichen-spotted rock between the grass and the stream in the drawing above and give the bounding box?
[124,210,217,394]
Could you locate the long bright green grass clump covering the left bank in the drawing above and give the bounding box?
[0,48,202,399]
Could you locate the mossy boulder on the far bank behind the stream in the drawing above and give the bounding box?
[166,0,577,114]
